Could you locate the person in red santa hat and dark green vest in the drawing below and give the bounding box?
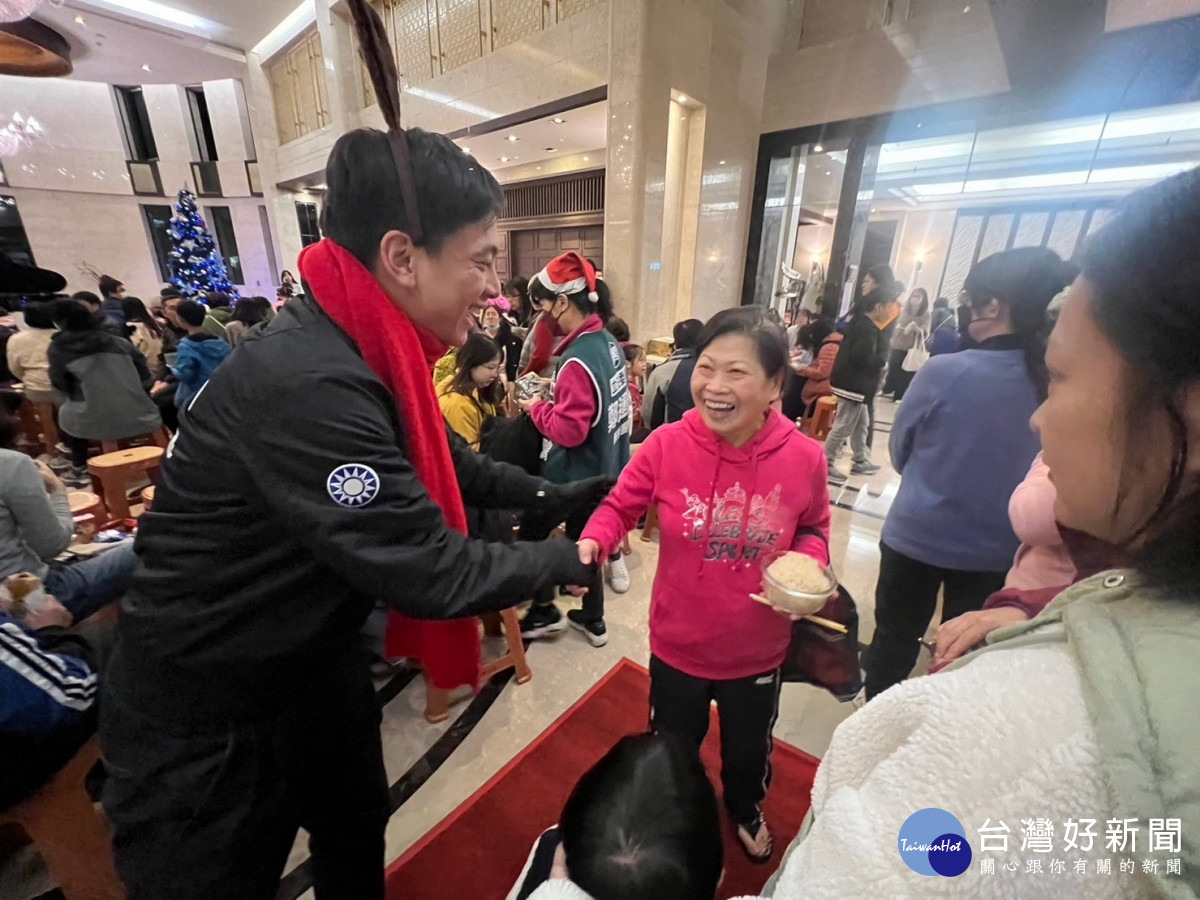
[521,253,632,647]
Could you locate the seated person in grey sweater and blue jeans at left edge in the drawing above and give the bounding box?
[0,408,137,622]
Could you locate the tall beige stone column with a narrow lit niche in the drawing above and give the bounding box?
[605,0,778,341]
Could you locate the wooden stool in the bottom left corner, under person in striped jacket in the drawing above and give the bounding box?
[0,738,125,900]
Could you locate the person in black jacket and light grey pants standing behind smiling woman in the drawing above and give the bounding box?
[826,294,890,485]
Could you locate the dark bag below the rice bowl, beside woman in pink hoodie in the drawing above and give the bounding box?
[780,584,863,702]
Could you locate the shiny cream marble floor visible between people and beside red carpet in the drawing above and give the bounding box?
[278,398,924,900]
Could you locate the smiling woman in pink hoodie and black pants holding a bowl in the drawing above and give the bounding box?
[580,307,829,862]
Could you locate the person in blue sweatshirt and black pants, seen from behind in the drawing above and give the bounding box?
[865,247,1074,698]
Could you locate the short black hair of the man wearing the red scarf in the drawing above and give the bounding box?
[320,128,504,268]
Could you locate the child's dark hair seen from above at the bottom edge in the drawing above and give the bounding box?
[558,734,724,900]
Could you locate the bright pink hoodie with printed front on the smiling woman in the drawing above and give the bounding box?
[583,409,829,680]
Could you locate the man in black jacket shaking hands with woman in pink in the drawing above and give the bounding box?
[101,123,606,900]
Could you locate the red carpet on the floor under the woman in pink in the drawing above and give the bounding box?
[388,659,820,900]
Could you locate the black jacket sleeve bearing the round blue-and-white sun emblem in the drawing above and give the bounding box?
[236,373,590,619]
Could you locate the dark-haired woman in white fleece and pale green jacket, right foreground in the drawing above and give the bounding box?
[539,169,1200,900]
